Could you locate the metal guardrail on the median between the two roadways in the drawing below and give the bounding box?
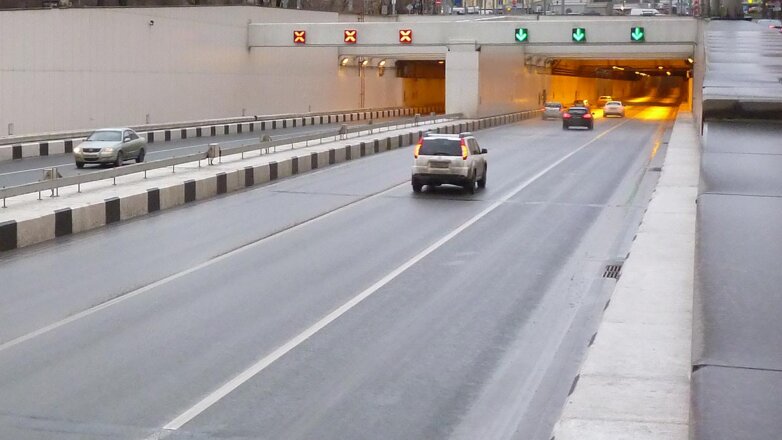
[0,113,462,208]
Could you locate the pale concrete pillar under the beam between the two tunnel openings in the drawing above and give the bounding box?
[445,43,480,118]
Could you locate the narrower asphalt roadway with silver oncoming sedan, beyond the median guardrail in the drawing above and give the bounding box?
[0,116,404,187]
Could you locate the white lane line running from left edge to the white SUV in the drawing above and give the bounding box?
[0,181,410,352]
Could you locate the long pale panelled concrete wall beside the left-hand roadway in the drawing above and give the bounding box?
[0,7,410,136]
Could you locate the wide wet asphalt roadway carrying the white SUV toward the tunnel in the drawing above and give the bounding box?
[0,107,674,440]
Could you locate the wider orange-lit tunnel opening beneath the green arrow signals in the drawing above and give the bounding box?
[545,59,692,108]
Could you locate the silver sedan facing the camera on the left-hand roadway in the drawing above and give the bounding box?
[73,128,147,168]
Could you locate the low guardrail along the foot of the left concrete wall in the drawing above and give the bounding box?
[0,107,434,145]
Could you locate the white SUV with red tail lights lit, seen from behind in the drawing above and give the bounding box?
[411,133,488,194]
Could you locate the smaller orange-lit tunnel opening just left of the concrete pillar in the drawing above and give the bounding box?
[396,60,445,112]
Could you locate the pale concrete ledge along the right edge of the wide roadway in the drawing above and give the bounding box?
[553,112,700,440]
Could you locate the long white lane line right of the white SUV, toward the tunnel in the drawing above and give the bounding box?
[163,115,627,431]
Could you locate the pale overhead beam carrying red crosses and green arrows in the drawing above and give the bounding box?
[248,17,697,52]
